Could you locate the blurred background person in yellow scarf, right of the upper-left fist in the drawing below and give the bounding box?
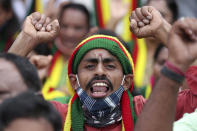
[42,3,90,103]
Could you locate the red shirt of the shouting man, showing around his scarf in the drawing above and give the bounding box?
[51,96,145,131]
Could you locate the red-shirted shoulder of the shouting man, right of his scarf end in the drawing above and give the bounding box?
[133,95,146,116]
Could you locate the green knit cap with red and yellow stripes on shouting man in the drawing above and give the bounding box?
[67,35,134,95]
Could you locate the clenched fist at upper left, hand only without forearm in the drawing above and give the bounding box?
[22,12,60,43]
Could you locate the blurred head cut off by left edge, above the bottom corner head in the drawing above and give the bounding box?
[0,53,41,103]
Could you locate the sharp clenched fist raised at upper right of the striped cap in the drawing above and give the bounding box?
[130,6,171,43]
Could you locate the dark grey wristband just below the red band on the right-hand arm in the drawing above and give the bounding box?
[161,66,185,84]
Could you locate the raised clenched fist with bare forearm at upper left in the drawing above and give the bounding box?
[8,12,60,56]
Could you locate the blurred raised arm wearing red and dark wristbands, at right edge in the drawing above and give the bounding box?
[135,18,197,131]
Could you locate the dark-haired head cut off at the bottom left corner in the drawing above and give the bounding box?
[0,92,62,131]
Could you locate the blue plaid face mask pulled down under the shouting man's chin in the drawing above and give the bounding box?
[77,85,124,128]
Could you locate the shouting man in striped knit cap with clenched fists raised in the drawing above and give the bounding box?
[10,7,196,131]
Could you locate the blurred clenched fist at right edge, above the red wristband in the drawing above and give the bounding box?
[168,18,197,71]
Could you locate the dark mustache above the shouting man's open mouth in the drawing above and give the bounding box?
[85,75,114,90]
